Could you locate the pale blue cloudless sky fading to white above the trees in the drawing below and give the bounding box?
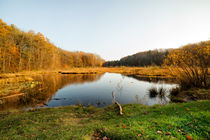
[0,0,210,60]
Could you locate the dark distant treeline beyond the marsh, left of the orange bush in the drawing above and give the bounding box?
[103,49,171,67]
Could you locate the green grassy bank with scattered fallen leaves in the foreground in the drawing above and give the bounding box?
[0,101,210,140]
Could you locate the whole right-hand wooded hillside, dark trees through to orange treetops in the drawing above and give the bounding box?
[103,41,210,67]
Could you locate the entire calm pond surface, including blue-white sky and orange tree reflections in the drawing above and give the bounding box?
[0,73,177,110]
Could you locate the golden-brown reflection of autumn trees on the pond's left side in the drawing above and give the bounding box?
[0,74,103,110]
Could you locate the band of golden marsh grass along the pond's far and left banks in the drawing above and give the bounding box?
[0,67,172,98]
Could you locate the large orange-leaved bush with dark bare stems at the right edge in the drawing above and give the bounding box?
[165,41,210,88]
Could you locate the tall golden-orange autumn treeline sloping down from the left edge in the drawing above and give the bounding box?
[0,19,104,73]
